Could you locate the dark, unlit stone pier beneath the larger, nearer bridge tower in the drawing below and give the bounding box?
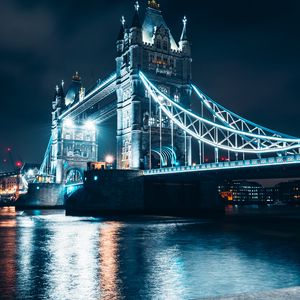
[66,170,223,216]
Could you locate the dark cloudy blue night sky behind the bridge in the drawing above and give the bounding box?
[0,0,300,170]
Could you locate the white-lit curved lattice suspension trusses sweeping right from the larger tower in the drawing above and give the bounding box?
[140,72,300,154]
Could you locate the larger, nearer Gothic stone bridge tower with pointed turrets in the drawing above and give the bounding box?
[116,0,192,169]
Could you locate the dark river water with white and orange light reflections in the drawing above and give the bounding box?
[0,208,300,300]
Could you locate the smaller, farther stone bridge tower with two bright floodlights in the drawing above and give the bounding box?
[50,72,98,183]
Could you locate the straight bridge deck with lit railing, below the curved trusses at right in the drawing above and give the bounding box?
[144,154,300,180]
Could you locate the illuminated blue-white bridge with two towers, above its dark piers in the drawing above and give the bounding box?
[40,0,300,183]
